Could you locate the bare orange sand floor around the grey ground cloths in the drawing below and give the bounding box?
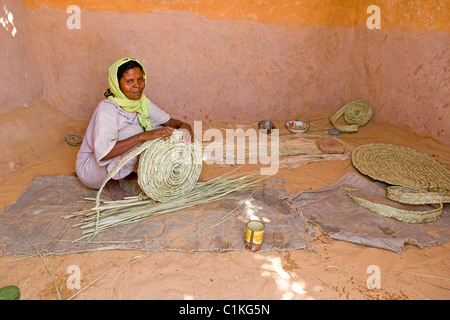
[0,119,450,300]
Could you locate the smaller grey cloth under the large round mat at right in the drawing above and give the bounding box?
[290,173,450,253]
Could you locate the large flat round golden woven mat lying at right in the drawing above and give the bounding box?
[352,143,450,194]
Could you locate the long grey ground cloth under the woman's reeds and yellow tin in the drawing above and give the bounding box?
[0,176,313,255]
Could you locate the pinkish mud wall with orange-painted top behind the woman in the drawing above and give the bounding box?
[0,0,450,144]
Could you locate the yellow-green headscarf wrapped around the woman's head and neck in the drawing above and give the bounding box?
[108,58,152,131]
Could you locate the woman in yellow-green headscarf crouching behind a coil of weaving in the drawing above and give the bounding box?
[75,58,194,200]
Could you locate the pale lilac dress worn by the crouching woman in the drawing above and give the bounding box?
[75,99,170,189]
